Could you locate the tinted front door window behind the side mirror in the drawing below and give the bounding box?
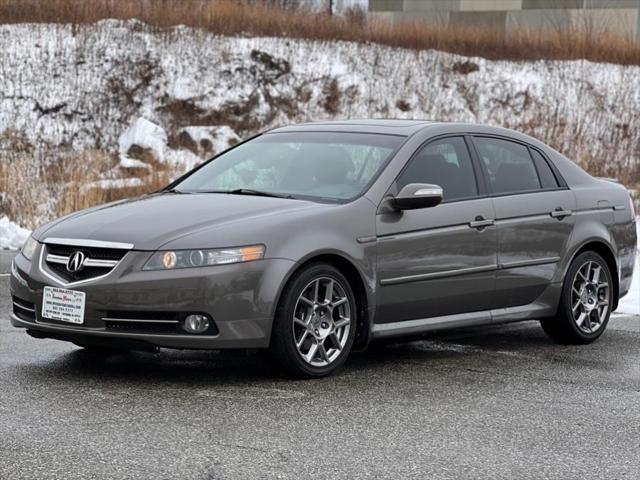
[398,137,478,200]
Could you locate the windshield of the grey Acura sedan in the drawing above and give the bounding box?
[173,132,404,201]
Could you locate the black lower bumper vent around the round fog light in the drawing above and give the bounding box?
[102,310,218,336]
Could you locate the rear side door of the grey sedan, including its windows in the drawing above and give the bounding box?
[473,136,576,307]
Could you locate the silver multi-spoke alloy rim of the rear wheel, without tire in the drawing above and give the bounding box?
[571,261,611,333]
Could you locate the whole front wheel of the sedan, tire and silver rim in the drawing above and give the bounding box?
[270,263,357,378]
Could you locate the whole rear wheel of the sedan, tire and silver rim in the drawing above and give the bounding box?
[541,252,613,344]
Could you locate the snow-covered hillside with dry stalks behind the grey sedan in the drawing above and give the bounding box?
[0,20,640,180]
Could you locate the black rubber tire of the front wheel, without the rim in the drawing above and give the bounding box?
[269,263,358,378]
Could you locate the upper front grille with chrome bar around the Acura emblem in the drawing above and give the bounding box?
[43,244,128,283]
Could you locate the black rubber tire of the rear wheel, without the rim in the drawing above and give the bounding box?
[540,251,615,345]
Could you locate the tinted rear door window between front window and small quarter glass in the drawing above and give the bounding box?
[474,137,540,193]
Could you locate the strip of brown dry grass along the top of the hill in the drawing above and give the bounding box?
[0,0,640,65]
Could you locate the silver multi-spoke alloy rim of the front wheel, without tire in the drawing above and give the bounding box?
[293,277,351,367]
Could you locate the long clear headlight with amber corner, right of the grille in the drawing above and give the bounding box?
[142,245,264,270]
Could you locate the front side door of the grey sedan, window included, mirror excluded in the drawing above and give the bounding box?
[375,136,497,323]
